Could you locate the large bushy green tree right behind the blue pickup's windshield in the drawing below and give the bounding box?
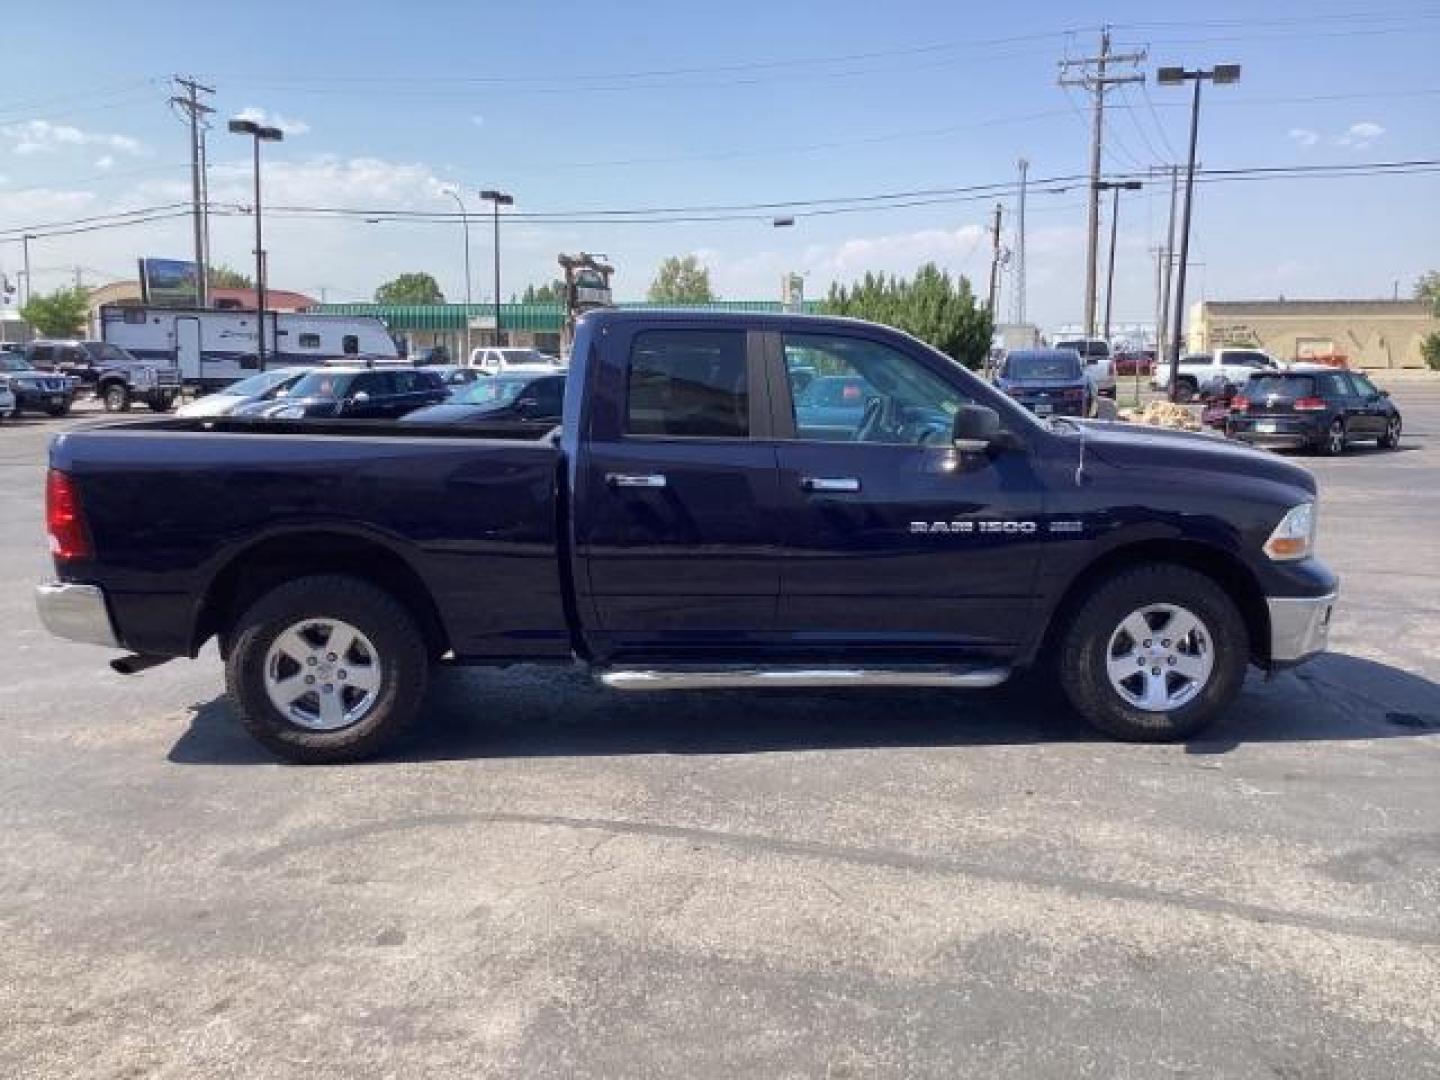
[822,262,995,369]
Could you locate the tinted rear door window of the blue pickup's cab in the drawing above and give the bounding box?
[625,330,750,439]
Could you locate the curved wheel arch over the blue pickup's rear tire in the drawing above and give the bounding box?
[190,527,449,657]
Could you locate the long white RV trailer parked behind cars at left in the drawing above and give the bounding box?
[99,304,399,390]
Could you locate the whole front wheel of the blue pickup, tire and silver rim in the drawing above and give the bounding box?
[1058,563,1250,742]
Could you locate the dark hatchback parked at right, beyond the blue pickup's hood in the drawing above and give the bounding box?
[1225,367,1401,454]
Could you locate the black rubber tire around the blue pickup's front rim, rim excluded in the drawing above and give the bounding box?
[1057,563,1250,743]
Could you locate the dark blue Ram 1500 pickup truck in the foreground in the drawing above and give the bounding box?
[39,311,1338,762]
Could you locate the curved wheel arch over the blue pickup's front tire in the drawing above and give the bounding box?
[1037,539,1270,664]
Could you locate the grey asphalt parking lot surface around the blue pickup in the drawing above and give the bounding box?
[0,382,1440,1079]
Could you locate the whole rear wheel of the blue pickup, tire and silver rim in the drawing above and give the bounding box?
[225,575,429,765]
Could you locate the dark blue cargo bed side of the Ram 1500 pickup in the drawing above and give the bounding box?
[52,418,570,658]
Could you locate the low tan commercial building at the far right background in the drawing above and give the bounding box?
[1189,300,1440,369]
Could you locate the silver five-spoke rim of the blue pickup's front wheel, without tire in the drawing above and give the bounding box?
[1104,603,1215,713]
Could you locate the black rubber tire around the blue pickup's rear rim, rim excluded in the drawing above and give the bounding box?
[225,575,429,765]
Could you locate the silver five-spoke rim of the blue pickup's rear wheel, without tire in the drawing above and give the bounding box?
[265,619,383,732]
